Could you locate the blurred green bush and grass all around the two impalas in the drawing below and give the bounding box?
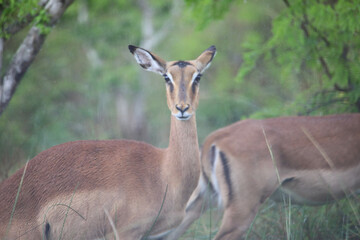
[0,0,360,239]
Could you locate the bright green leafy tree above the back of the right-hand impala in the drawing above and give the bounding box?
[238,0,360,114]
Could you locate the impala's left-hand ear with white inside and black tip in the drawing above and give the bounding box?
[129,45,166,75]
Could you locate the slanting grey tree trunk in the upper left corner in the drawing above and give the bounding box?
[0,0,74,116]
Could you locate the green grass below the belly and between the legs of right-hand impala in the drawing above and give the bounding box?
[181,198,360,240]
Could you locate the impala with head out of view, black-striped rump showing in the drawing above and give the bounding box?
[167,114,360,240]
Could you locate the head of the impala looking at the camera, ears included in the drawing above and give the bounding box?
[129,45,216,120]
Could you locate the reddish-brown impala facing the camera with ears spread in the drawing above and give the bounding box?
[0,45,216,240]
